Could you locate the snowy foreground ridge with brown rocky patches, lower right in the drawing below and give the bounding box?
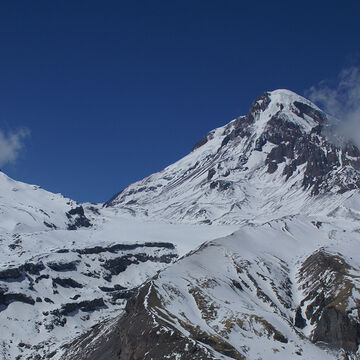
[62,212,360,360]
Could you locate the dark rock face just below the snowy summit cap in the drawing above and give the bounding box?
[223,93,360,195]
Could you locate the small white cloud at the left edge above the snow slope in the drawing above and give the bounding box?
[0,128,30,166]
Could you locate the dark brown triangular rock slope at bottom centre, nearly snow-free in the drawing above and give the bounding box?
[62,283,231,360]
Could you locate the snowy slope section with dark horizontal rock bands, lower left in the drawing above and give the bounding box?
[0,242,178,360]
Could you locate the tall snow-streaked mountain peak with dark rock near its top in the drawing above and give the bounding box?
[105,90,360,224]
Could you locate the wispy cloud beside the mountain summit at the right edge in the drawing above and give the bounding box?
[306,66,360,146]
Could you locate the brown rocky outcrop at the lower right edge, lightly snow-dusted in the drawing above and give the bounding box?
[299,249,360,352]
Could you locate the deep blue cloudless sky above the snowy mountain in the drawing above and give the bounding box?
[0,0,360,202]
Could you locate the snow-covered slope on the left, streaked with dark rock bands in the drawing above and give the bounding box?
[0,173,235,359]
